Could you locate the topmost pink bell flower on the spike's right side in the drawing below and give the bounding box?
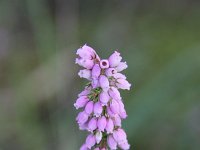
[108,51,122,67]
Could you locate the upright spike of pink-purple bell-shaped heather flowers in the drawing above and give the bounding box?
[74,45,131,150]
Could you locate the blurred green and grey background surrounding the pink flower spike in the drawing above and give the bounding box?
[0,0,200,150]
